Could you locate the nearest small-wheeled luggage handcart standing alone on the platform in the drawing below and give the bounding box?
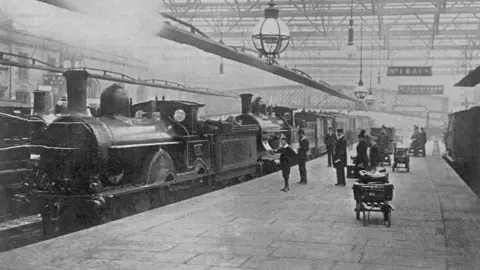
[353,179,394,227]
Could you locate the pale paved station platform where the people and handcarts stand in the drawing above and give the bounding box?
[0,142,480,270]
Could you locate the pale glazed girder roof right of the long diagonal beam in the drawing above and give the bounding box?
[163,0,480,85]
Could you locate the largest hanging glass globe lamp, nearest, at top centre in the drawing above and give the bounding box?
[252,0,290,65]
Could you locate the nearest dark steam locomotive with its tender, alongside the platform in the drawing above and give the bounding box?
[32,71,258,235]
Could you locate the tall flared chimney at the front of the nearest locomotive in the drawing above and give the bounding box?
[63,70,90,115]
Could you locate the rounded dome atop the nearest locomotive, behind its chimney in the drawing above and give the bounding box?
[100,84,130,117]
